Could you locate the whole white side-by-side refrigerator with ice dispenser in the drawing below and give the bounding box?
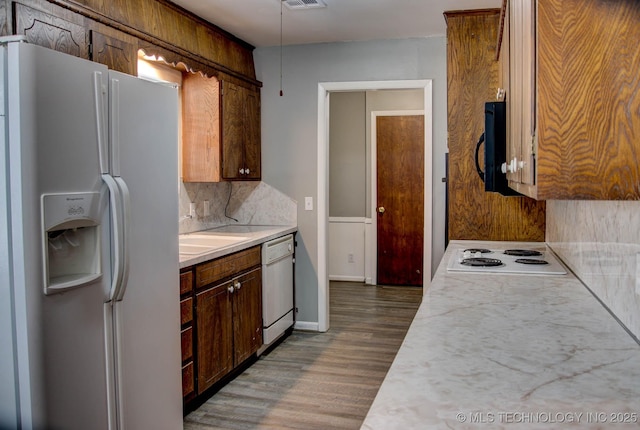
[0,37,182,430]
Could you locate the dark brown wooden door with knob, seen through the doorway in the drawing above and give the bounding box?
[371,111,425,286]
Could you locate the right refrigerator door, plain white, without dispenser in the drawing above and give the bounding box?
[109,71,182,430]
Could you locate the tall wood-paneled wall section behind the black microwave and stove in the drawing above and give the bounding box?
[445,9,545,241]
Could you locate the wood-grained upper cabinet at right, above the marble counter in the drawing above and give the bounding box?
[507,0,640,200]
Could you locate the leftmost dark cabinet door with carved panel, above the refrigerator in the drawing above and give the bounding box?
[13,3,89,59]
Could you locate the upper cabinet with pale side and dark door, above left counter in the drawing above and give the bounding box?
[182,73,261,182]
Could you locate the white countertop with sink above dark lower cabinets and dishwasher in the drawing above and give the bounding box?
[180,224,298,269]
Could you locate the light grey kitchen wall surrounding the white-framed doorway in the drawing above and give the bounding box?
[254,36,447,322]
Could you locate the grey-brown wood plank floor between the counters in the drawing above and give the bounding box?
[184,282,422,430]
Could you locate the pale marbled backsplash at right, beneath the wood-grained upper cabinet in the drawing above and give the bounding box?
[546,200,640,338]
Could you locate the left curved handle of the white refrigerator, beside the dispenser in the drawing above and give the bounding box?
[102,174,124,301]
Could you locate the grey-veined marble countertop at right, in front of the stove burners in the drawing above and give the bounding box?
[362,241,640,430]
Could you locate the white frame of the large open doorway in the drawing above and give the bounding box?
[316,79,433,332]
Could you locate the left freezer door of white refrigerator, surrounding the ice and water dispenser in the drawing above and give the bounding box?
[5,43,111,429]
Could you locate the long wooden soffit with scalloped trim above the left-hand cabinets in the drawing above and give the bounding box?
[0,0,261,86]
